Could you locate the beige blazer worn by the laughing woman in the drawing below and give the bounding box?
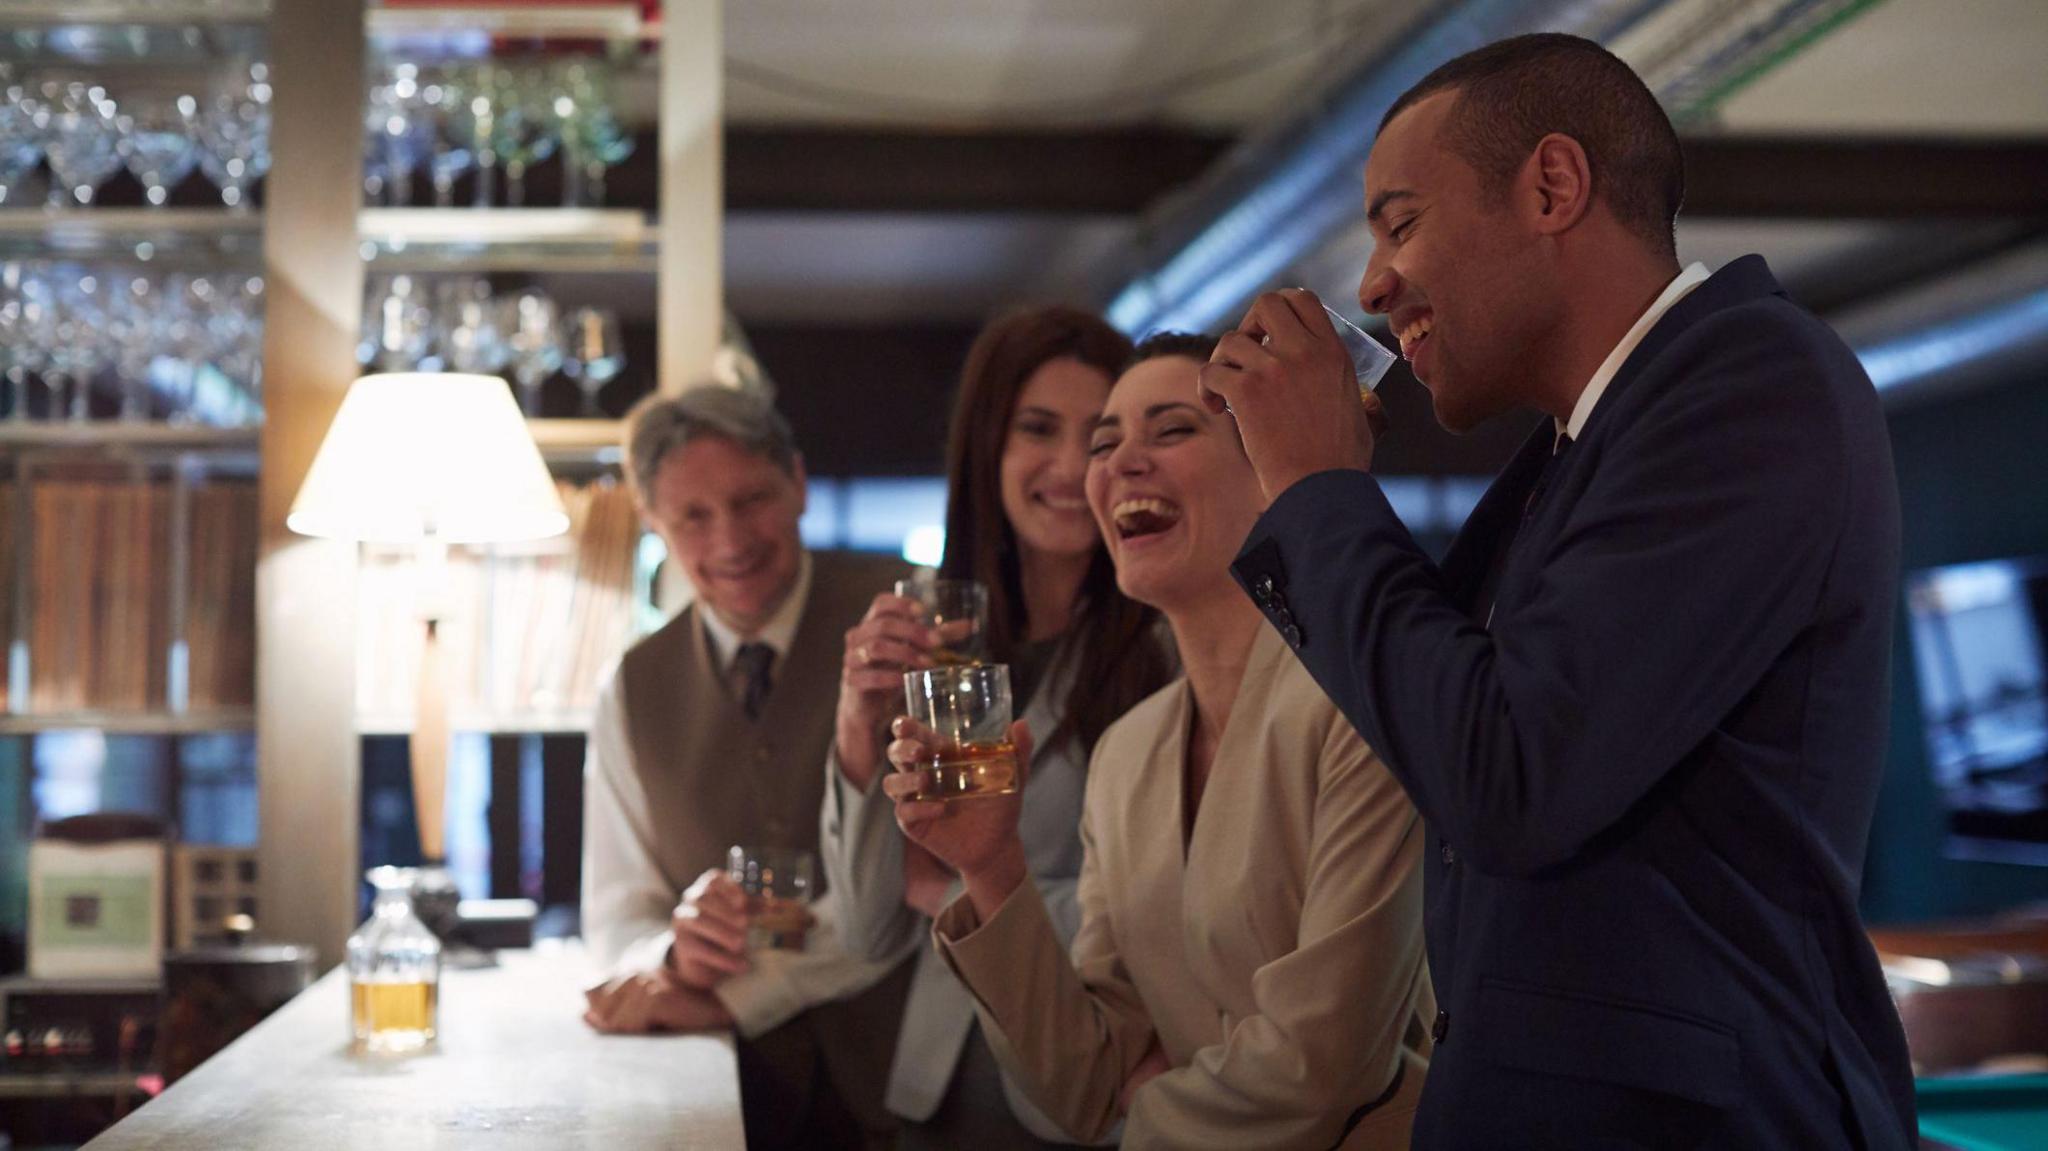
[932,627,1436,1151]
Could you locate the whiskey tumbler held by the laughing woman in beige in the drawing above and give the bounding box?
[903,664,1018,799]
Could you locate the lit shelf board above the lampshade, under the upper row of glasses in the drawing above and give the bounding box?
[356,207,659,272]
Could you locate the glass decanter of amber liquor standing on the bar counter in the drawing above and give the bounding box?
[348,866,440,1055]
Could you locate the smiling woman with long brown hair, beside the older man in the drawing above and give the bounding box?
[821,307,1174,1151]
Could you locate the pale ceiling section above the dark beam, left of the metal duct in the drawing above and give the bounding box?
[725,0,1423,127]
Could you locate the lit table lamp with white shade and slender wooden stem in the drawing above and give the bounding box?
[285,373,569,864]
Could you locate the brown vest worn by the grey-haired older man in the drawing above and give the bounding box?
[618,551,905,895]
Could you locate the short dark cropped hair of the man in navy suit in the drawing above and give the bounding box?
[1380,33,1686,258]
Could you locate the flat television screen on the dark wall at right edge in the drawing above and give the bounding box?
[1907,557,2048,864]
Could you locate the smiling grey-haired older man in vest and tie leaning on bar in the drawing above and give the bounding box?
[584,387,909,1149]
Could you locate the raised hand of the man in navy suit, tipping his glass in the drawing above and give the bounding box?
[1198,289,1386,500]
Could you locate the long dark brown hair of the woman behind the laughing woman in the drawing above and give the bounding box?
[940,305,1174,752]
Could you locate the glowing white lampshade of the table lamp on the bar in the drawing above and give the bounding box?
[285,373,569,543]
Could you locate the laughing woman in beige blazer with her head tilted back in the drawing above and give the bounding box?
[885,336,1434,1149]
